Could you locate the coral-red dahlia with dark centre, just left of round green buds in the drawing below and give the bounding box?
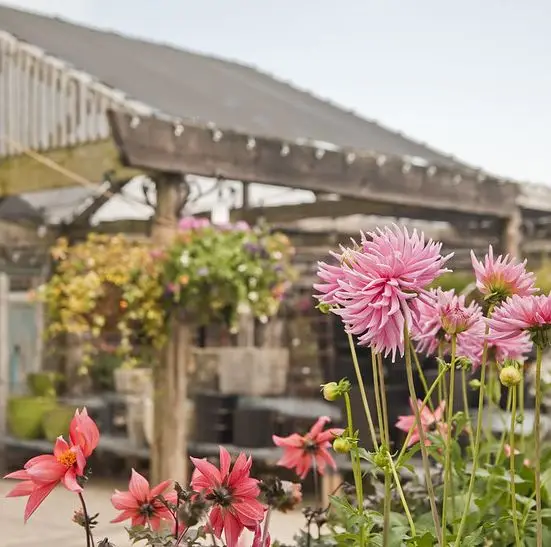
[272,416,344,479]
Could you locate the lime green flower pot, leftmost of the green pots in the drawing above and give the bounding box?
[7,397,57,440]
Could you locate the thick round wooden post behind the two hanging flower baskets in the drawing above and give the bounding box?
[150,174,193,485]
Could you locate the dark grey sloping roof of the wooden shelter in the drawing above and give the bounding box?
[0,5,472,167]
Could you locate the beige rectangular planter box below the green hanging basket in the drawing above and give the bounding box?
[218,347,289,396]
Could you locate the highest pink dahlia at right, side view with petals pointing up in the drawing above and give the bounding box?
[471,245,537,302]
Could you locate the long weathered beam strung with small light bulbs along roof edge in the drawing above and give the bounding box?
[108,111,518,218]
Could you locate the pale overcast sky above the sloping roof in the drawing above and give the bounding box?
[4,0,551,183]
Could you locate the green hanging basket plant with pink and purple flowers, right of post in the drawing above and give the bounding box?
[161,218,294,330]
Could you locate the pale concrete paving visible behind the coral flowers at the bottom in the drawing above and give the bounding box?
[0,480,304,547]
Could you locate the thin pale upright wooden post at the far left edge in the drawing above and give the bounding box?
[0,273,10,475]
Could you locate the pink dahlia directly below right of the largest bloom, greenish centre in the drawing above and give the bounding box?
[412,289,484,365]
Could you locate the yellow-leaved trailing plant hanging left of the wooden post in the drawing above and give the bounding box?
[36,234,165,369]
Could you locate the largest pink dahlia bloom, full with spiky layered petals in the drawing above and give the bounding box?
[335,226,452,358]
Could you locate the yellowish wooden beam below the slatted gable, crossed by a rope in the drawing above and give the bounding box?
[0,139,143,196]
